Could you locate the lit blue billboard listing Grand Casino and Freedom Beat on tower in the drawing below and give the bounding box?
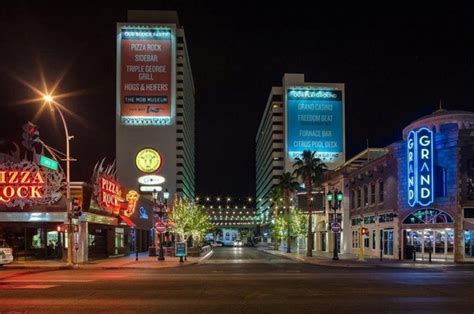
[286,85,345,168]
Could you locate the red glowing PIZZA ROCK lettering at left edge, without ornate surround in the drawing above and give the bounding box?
[0,169,45,203]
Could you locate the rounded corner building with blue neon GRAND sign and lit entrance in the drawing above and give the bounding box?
[395,109,474,262]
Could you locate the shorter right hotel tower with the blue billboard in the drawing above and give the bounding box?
[256,74,345,231]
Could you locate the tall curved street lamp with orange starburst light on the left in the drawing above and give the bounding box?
[43,94,74,265]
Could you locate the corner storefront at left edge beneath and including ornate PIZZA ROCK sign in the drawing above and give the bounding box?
[0,159,67,261]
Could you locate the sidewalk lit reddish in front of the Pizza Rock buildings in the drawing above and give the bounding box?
[3,251,214,270]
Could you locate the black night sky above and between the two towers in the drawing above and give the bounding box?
[0,1,474,196]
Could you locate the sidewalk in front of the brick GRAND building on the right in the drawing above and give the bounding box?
[258,246,462,269]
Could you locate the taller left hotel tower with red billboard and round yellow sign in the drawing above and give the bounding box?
[116,11,195,198]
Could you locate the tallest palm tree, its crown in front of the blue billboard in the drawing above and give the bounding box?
[293,150,327,256]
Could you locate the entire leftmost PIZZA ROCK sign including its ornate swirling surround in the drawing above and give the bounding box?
[0,160,64,208]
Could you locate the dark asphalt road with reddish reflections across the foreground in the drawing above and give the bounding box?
[0,248,474,314]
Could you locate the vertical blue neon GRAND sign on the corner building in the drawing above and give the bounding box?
[407,128,434,207]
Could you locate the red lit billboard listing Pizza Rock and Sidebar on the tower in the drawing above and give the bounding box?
[117,24,175,125]
